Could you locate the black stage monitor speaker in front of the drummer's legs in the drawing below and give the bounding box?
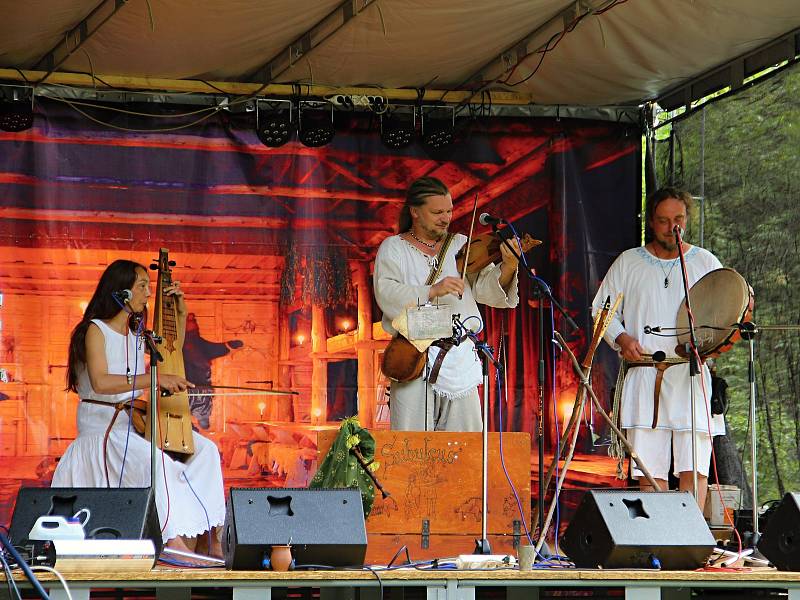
[561,490,716,569]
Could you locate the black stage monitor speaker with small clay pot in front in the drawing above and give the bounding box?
[223,488,367,570]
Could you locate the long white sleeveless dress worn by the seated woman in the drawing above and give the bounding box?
[51,319,225,542]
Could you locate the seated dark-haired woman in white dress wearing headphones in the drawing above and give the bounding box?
[52,260,225,557]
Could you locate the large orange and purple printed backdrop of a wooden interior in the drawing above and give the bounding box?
[0,101,641,523]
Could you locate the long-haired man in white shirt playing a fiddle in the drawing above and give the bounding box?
[373,177,519,431]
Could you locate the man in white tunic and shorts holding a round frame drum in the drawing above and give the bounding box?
[592,187,724,507]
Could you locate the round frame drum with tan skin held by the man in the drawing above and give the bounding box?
[676,268,754,358]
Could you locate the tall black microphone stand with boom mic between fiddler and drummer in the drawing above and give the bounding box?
[484,224,579,548]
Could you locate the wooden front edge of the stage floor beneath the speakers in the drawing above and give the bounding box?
[0,567,800,600]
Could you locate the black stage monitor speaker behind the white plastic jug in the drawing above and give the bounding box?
[8,488,162,556]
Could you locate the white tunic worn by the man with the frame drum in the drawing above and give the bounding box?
[592,246,724,435]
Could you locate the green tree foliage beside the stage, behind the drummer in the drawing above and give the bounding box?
[657,65,800,503]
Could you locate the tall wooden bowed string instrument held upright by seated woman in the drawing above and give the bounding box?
[139,248,194,456]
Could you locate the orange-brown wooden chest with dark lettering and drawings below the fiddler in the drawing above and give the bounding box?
[318,431,531,564]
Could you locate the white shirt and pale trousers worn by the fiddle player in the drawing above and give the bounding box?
[373,234,519,431]
